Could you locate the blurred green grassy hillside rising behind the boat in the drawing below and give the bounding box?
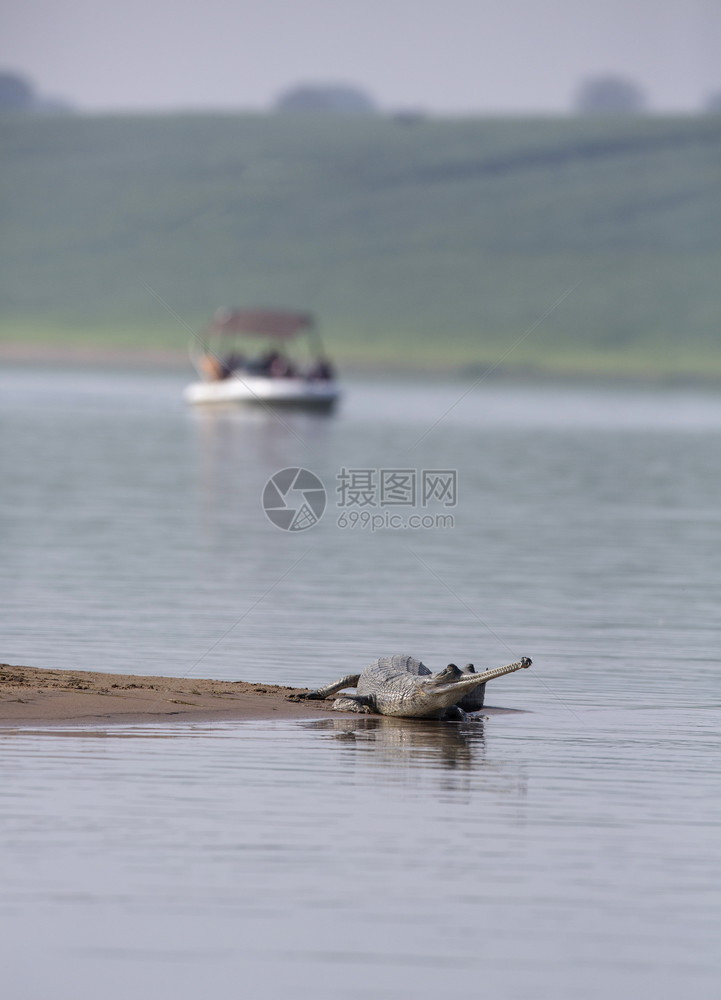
[0,115,721,376]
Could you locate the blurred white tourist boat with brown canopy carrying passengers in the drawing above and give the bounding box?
[183,309,340,412]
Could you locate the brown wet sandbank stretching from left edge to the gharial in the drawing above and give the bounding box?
[0,663,344,727]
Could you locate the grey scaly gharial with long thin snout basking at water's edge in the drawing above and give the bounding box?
[293,654,531,720]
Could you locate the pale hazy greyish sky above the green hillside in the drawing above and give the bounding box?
[0,0,721,113]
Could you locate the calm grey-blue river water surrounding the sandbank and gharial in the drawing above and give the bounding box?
[0,368,721,1000]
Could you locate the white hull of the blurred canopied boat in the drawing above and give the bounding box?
[183,374,340,410]
